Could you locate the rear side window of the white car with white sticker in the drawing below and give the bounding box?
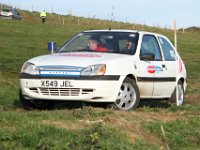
[158,37,175,61]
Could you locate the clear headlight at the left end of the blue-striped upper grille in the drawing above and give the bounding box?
[21,62,39,75]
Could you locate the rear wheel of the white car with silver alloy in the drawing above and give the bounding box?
[169,80,184,106]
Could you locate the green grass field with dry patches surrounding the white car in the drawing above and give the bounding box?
[0,11,200,150]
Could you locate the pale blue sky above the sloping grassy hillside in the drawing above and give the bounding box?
[0,0,200,28]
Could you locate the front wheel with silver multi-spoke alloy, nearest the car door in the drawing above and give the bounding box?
[115,78,140,110]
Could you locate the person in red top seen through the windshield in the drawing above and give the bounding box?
[88,36,108,52]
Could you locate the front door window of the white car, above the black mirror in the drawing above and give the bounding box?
[140,35,162,60]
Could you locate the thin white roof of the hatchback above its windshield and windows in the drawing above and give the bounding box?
[83,29,165,37]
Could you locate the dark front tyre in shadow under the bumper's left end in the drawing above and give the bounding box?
[19,90,54,110]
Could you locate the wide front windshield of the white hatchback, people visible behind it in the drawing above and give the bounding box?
[58,31,138,55]
